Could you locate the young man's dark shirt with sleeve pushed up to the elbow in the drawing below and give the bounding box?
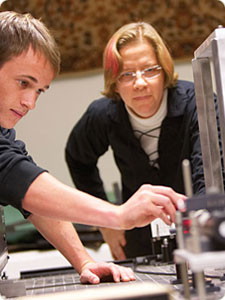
[0,127,45,217]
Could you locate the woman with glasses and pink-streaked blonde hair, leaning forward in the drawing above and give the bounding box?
[66,22,205,259]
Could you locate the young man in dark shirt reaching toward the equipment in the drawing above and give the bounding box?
[0,12,184,283]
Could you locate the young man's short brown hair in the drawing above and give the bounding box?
[0,11,60,75]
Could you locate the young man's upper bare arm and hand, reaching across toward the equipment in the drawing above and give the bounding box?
[22,173,185,229]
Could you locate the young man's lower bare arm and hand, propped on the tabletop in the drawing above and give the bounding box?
[29,214,135,284]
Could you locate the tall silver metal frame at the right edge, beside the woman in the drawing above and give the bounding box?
[192,28,225,192]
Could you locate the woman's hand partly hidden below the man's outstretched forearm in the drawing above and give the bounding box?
[100,228,126,260]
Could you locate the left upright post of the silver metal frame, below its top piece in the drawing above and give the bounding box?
[192,58,223,192]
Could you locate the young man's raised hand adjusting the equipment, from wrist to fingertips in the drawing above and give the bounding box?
[119,184,186,229]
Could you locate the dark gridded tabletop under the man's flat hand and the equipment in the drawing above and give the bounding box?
[4,260,225,300]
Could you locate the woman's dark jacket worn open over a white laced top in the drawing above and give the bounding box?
[66,81,205,256]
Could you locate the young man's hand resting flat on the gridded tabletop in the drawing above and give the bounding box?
[80,262,135,284]
